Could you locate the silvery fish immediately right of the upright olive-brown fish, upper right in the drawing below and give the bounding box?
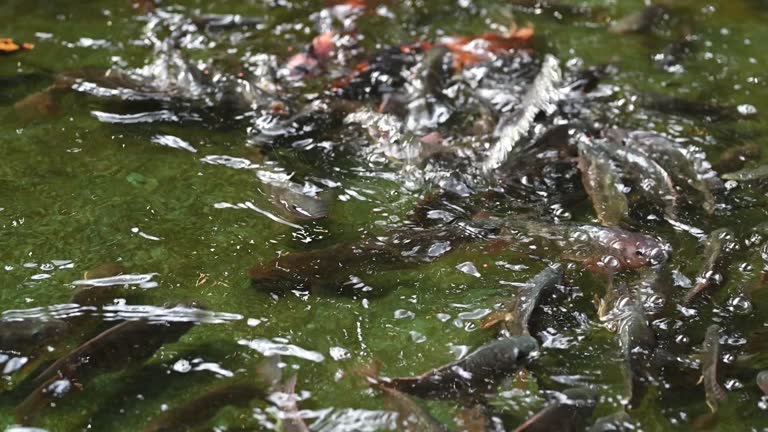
[599,135,680,220]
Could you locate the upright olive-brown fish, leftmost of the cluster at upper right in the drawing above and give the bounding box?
[578,139,629,226]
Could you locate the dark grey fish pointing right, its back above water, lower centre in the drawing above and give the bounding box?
[380,336,539,398]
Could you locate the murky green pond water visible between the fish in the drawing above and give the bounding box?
[0,0,768,431]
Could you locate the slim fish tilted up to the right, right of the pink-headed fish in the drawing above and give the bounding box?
[684,228,738,304]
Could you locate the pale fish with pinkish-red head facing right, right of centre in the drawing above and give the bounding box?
[494,218,671,273]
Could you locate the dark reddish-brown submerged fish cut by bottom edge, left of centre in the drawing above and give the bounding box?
[144,383,266,432]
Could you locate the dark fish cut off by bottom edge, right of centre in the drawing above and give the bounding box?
[513,387,597,432]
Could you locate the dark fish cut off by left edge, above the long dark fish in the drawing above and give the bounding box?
[0,318,67,355]
